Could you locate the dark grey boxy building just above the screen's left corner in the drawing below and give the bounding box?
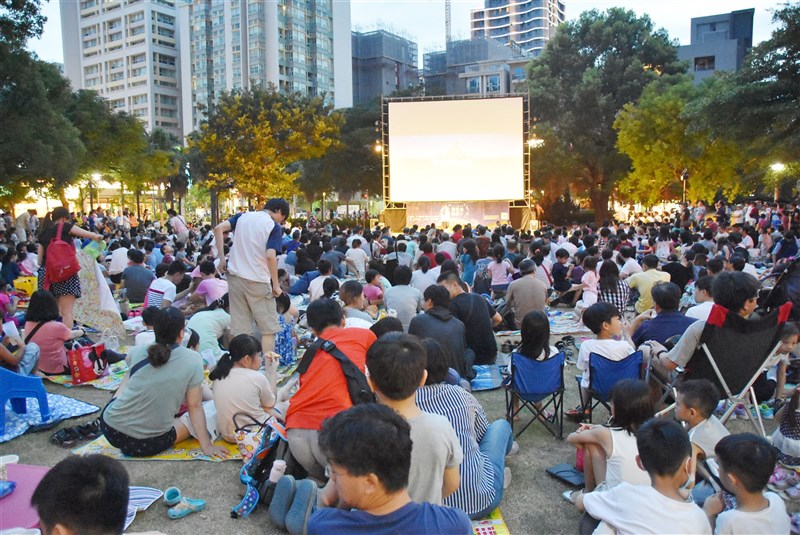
[352,30,419,104]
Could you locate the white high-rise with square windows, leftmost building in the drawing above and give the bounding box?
[60,0,181,136]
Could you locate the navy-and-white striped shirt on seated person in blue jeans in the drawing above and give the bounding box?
[417,383,496,514]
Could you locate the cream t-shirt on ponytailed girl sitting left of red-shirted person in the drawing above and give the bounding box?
[211,368,275,442]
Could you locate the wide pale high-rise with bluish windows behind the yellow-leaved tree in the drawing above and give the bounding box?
[178,0,353,138]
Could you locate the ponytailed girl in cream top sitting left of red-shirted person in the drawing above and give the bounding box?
[210,334,283,444]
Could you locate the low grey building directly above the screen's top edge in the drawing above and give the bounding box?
[423,38,532,96]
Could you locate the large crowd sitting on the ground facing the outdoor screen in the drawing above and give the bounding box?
[0,199,800,534]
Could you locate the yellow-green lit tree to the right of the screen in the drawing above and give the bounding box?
[614,77,757,205]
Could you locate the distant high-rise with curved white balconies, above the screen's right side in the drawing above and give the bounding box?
[470,0,566,56]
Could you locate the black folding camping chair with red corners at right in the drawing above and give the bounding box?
[659,303,792,437]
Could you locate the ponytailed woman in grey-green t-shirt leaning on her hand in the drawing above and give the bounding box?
[100,307,228,457]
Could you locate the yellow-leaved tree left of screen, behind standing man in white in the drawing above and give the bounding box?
[194,85,342,201]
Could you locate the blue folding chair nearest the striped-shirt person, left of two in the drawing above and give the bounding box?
[503,353,564,439]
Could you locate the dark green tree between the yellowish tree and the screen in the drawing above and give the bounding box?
[297,101,383,200]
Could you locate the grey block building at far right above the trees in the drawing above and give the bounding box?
[678,9,755,84]
